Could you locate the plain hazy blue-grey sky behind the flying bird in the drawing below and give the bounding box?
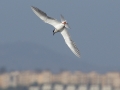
[0,0,120,70]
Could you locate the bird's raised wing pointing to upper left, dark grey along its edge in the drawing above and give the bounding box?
[31,6,60,28]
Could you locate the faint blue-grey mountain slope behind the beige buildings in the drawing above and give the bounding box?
[0,42,109,72]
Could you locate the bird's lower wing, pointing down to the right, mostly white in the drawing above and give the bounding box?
[61,28,80,58]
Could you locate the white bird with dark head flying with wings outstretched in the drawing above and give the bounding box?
[31,6,80,58]
